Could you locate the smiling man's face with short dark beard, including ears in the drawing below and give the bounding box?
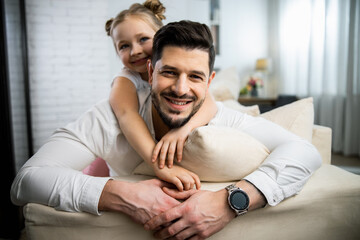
[148,46,215,128]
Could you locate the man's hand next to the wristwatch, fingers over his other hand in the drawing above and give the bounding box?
[145,188,235,239]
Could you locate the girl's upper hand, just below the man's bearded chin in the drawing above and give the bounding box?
[151,126,191,168]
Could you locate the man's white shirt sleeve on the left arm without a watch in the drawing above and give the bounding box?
[11,100,113,214]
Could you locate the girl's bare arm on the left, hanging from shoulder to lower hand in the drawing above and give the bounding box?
[110,77,200,191]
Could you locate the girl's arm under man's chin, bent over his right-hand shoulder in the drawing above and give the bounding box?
[151,91,217,168]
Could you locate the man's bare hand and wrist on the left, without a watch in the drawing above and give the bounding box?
[99,179,180,224]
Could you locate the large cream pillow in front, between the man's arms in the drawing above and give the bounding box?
[134,126,269,182]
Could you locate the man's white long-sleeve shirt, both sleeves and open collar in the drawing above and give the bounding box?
[11,88,321,214]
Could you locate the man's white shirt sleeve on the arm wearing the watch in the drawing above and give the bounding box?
[210,102,321,206]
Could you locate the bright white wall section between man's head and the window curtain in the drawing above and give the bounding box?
[215,0,268,84]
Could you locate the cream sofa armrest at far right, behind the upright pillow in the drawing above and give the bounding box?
[312,125,332,164]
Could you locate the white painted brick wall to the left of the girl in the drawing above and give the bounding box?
[26,0,114,151]
